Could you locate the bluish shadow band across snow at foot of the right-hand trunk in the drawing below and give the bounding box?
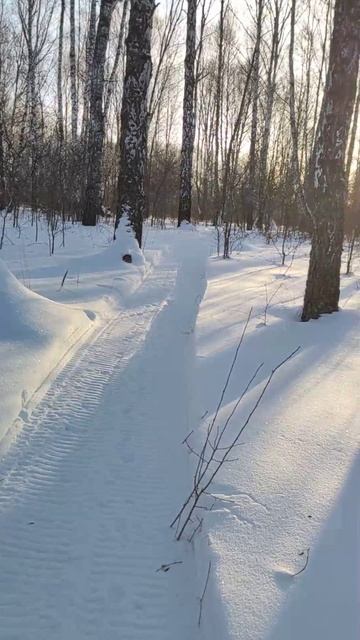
[197,307,360,438]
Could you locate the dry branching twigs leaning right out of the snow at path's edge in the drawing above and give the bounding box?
[171,346,300,540]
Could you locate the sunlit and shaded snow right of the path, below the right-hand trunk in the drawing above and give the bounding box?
[195,239,360,640]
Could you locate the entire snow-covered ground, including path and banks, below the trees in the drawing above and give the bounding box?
[0,218,360,640]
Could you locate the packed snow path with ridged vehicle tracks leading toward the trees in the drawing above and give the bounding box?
[0,233,207,640]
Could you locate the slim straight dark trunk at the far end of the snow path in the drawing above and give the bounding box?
[178,0,197,226]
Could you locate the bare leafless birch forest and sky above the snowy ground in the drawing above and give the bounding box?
[0,0,360,319]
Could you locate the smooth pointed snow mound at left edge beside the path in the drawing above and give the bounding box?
[0,260,91,448]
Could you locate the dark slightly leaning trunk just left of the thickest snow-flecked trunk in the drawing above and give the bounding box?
[82,0,117,226]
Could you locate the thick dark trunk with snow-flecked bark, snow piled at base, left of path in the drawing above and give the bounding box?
[116,0,155,247]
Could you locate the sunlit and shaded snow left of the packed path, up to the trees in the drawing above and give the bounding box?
[0,215,148,445]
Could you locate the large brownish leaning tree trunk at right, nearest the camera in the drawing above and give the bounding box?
[302,0,360,321]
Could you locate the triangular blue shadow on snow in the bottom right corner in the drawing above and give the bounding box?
[263,454,360,640]
